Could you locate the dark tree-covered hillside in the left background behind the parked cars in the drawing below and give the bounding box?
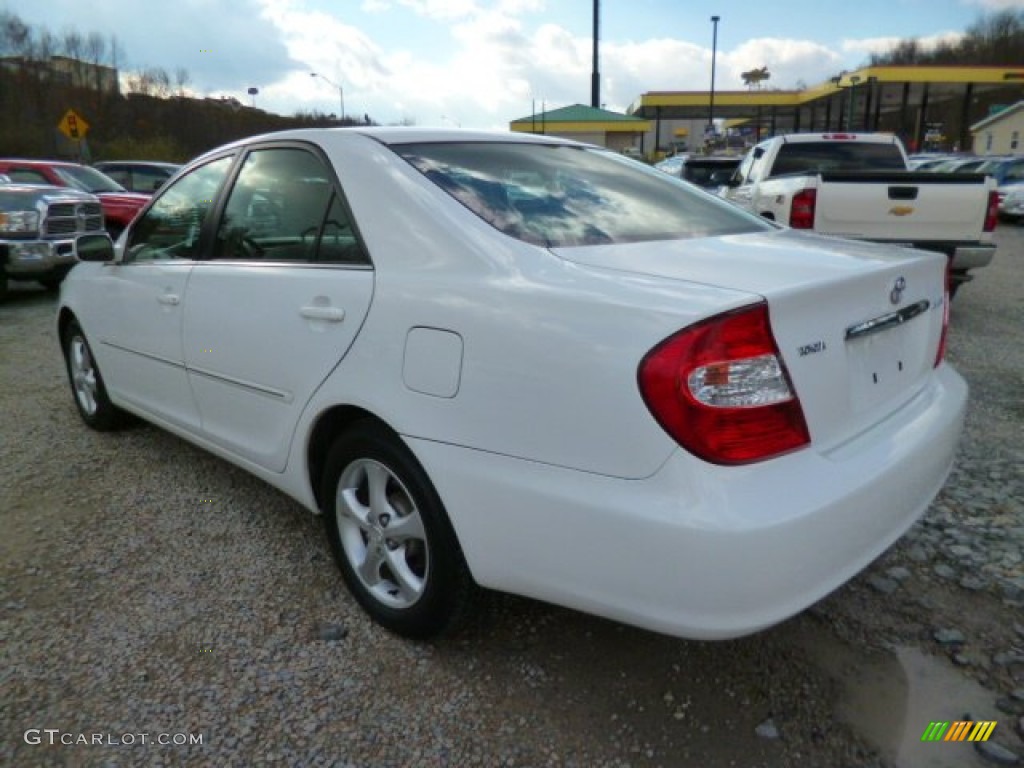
[0,11,372,162]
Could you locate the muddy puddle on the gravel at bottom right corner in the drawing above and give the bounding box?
[798,632,1012,768]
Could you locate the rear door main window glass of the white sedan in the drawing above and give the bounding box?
[214,147,334,261]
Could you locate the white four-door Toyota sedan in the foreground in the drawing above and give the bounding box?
[57,128,967,638]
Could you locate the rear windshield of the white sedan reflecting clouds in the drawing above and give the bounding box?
[392,142,771,248]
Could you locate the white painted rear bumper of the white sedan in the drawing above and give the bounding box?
[409,366,967,639]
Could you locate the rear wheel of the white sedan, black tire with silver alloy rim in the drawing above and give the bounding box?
[321,421,478,640]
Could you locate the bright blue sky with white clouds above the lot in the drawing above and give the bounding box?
[8,0,1024,129]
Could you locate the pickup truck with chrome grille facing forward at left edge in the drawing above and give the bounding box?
[0,178,103,298]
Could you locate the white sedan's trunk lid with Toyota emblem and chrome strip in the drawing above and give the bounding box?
[554,231,945,452]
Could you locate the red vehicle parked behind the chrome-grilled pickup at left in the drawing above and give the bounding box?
[0,158,151,240]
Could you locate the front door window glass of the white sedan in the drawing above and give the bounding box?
[125,156,233,261]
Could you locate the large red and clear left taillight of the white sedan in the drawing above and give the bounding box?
[637,302,811,464]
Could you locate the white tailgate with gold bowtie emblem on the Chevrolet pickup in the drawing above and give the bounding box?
[814,172,989,243]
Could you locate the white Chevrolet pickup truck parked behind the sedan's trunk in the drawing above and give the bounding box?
[724,133,998,292]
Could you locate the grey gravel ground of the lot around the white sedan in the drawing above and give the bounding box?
[0,227,1024,768]
